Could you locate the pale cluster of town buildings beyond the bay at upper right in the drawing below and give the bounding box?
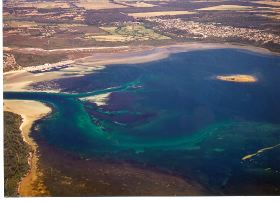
[147,18,280,44]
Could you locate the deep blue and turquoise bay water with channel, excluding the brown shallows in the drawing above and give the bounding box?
[4,49,280,194]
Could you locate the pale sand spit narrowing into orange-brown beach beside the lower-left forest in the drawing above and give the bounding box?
[4,100,51,196]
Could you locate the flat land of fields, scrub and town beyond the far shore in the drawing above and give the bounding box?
[3,0,280,51]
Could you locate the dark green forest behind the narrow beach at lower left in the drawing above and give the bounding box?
[4,112,30,196]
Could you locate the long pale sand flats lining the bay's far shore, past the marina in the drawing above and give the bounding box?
[4,43,279,92]
